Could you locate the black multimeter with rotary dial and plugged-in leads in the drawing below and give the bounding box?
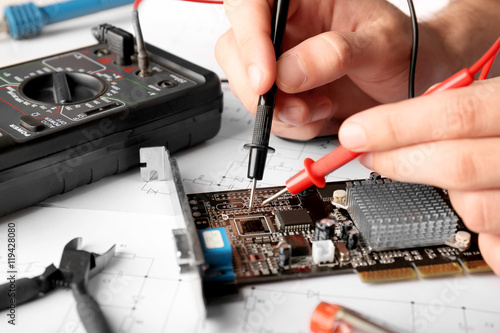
[0,25,222,216]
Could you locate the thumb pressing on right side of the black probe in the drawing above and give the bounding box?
[276,31,380,94]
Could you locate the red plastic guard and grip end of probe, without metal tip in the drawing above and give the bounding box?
[286,146,361,194]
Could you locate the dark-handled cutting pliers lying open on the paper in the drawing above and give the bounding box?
[0,237,115,333]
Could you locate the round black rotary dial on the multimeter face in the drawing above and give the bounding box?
[19,72,107,105]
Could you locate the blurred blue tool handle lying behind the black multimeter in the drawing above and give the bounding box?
[0,0,134,39]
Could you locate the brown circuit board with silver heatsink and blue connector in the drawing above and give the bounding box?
[188,175,490,285]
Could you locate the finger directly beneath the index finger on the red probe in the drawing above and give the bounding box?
[362,137,500,191]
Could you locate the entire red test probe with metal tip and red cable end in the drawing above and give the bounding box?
[262,38,500,206]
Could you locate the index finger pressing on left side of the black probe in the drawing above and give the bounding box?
[224,0,290,94]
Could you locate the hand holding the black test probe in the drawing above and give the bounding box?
[216,0,454,140]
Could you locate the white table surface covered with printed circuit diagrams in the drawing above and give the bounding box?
[0,0,500,333]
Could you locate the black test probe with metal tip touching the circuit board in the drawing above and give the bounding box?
[245,0,289,212]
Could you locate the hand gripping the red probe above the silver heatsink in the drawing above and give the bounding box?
[339,78,500,275]
